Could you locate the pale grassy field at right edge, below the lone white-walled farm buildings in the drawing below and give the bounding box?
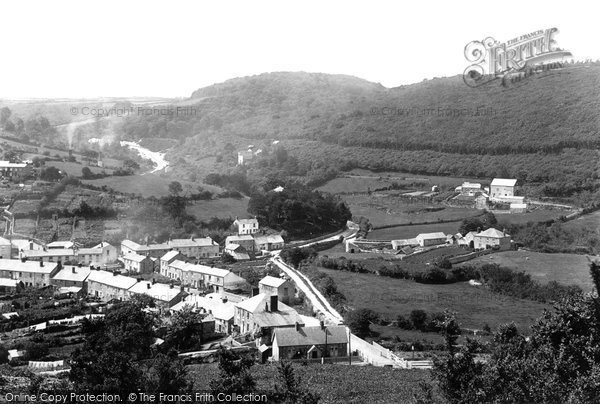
[462,251,592,291]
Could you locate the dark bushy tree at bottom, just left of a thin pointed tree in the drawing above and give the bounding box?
[210,347,256,394]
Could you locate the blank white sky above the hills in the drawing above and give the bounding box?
[0,0,600,98]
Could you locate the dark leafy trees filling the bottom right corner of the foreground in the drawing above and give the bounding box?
[433,263,600,403]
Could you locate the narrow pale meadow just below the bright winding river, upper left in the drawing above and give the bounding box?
[83,174,222,197]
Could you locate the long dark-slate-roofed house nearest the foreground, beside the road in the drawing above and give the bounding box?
[272,324,348,361]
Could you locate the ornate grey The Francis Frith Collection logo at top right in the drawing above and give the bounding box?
[463,28,572,87]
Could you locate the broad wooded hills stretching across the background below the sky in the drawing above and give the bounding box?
[117,64,600,196]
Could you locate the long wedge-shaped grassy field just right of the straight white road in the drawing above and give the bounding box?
[320,269,549,332]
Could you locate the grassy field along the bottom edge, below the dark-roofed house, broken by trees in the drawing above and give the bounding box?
[188,364,431,404]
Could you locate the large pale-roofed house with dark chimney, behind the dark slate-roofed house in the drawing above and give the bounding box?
[233,293,304,346]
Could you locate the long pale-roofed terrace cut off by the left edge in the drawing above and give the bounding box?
[0,258,60,288]
